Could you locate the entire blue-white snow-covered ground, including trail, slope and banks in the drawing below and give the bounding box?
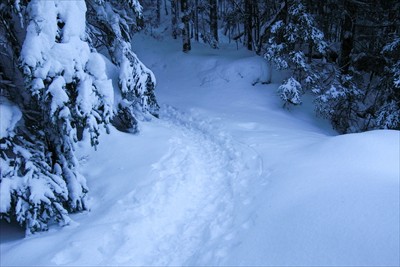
[0,36,400,266]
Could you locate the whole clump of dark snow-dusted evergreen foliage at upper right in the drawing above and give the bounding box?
[265,0,400,133]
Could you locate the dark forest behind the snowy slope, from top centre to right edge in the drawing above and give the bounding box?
[143,0,400,133]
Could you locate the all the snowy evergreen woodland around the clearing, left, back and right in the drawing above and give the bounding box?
[0,0,400,232]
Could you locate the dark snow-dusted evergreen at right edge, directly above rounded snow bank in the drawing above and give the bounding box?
[316,0,400,133]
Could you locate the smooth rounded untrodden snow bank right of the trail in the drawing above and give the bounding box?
[225,131,400,266]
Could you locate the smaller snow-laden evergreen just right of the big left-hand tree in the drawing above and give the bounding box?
[87,0,159,132]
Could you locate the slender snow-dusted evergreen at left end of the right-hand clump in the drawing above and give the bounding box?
[265,0,327,105]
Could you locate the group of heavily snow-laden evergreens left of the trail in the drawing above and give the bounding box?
[0,0,158,233]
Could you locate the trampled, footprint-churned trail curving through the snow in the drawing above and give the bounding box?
[53,106,262,266]
